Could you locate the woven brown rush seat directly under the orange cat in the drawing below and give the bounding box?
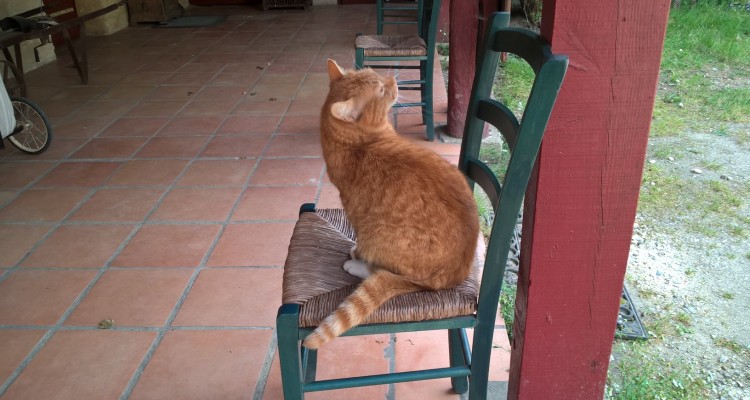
[282,209,479,327]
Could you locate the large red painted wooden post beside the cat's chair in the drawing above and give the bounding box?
[508,0,670,400]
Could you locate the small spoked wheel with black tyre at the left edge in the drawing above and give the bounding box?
[8,97,52,154]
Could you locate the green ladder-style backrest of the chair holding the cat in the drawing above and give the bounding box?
[459,12,568,332]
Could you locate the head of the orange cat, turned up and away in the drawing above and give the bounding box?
[324,59,398,124]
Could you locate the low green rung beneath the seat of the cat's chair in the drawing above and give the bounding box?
[302,366,471,392]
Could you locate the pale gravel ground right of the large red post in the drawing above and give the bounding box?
[627,126,750,400]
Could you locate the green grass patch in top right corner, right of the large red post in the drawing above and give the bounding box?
[651,1,750,140]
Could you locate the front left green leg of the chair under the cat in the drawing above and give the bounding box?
[276,304,305,400]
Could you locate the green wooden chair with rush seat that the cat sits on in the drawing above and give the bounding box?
[276,13,568,400]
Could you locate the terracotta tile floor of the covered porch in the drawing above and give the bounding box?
[0,6,509,400]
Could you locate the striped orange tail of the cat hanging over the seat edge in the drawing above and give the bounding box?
[302,270,422,349]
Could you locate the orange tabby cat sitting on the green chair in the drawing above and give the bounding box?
[304,60,479,349]
